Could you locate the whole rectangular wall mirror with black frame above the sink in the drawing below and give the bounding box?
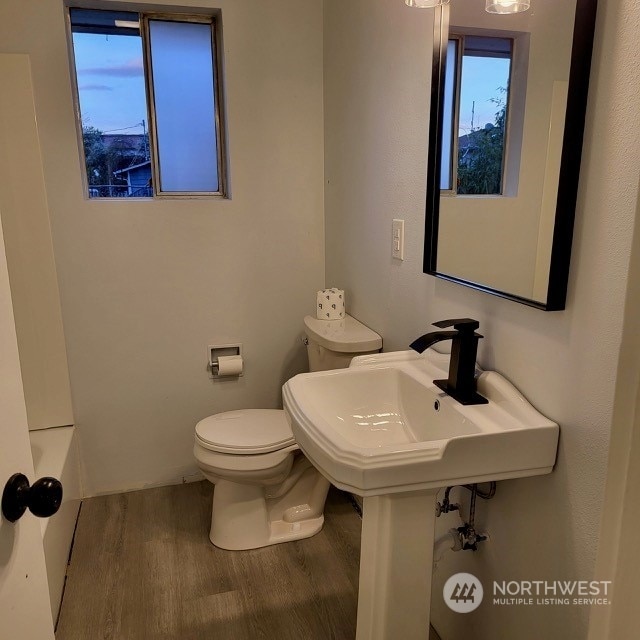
[425,0,596,310]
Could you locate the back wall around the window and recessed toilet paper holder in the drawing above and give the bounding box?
[0,0,324,495]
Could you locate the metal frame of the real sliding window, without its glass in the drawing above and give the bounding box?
[65,1,229,202]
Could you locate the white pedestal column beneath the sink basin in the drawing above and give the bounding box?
[356,490,437,640]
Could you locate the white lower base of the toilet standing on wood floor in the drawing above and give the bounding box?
[209,460,330,551]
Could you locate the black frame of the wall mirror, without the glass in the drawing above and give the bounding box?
[423,0,597,311]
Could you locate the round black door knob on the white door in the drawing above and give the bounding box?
[2,473,62,522]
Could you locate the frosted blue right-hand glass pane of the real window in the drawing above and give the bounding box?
[149,20,219,193]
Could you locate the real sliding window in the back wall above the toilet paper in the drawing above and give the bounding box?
[69,8,226,198]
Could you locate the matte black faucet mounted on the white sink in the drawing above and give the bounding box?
[409,318,488,404]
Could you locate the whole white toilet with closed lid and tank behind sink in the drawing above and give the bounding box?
[194,316,382,549]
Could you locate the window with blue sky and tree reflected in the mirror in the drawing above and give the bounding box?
[440,35,513,195]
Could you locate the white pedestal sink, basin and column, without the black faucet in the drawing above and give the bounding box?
[283,349,559,640]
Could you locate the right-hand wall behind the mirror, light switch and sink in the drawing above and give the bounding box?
[325,0,640,640]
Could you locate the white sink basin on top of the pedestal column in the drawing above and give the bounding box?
[283,352,559,496]
